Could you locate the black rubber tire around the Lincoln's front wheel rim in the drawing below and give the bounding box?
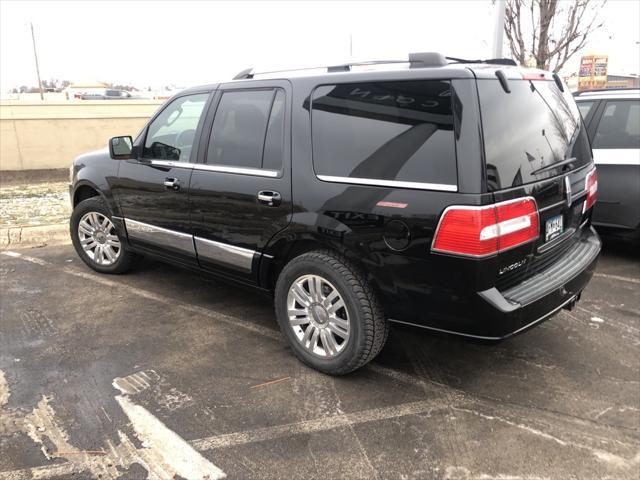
[69,197,137,273]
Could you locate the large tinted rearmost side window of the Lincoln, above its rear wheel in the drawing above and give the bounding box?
[311,81,457,190]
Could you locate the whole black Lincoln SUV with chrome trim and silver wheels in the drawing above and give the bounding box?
[71,53,600,374]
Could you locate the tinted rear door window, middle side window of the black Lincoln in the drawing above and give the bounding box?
[207,89,284,170]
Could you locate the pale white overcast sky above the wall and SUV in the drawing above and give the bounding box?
[0,0,640,91]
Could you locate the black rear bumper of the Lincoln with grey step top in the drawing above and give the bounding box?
[392,227,601,341]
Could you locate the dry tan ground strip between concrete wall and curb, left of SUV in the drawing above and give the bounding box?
[0,182,71,227]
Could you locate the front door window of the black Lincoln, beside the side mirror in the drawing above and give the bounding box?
[142,93,209,162]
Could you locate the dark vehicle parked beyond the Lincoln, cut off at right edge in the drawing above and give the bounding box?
[575,88,640,241]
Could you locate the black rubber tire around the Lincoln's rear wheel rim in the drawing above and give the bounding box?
[275,251,389,375]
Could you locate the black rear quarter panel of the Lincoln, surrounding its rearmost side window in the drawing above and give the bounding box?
[265,73,493,324]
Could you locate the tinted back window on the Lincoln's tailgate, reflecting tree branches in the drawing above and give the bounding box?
[478,80,591,190]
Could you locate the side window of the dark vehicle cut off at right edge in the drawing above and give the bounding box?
[593,100,640,148]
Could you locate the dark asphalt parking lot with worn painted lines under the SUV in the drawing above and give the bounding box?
[0,245,640,480]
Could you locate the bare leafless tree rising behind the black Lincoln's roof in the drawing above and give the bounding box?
[504,0,607,72]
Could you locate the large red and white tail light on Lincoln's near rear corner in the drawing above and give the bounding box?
[431,197,539,257]
